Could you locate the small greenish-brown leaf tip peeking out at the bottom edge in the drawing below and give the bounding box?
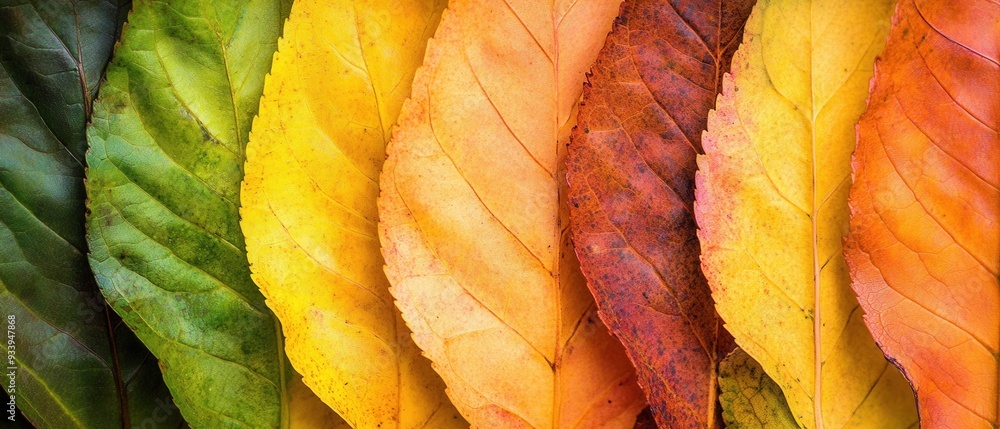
[719,348,799,429]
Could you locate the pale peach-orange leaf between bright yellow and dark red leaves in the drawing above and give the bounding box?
[379,0,645,428]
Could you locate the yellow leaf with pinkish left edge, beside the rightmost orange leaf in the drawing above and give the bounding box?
[695,0,916,429]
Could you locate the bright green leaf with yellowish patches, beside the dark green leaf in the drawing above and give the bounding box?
[87,0,306,429]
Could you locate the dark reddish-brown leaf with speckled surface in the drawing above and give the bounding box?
[567,0,754,428]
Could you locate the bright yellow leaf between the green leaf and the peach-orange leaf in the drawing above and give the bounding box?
[241,0,468,428]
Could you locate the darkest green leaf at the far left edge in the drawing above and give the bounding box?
[0,0,182,429]
